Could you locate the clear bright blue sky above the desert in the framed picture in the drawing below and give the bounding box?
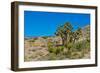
[24,11,90,37]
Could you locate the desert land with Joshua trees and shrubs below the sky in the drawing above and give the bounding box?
[24,22,90,62]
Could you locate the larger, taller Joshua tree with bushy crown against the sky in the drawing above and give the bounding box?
[56,22,73,45]
